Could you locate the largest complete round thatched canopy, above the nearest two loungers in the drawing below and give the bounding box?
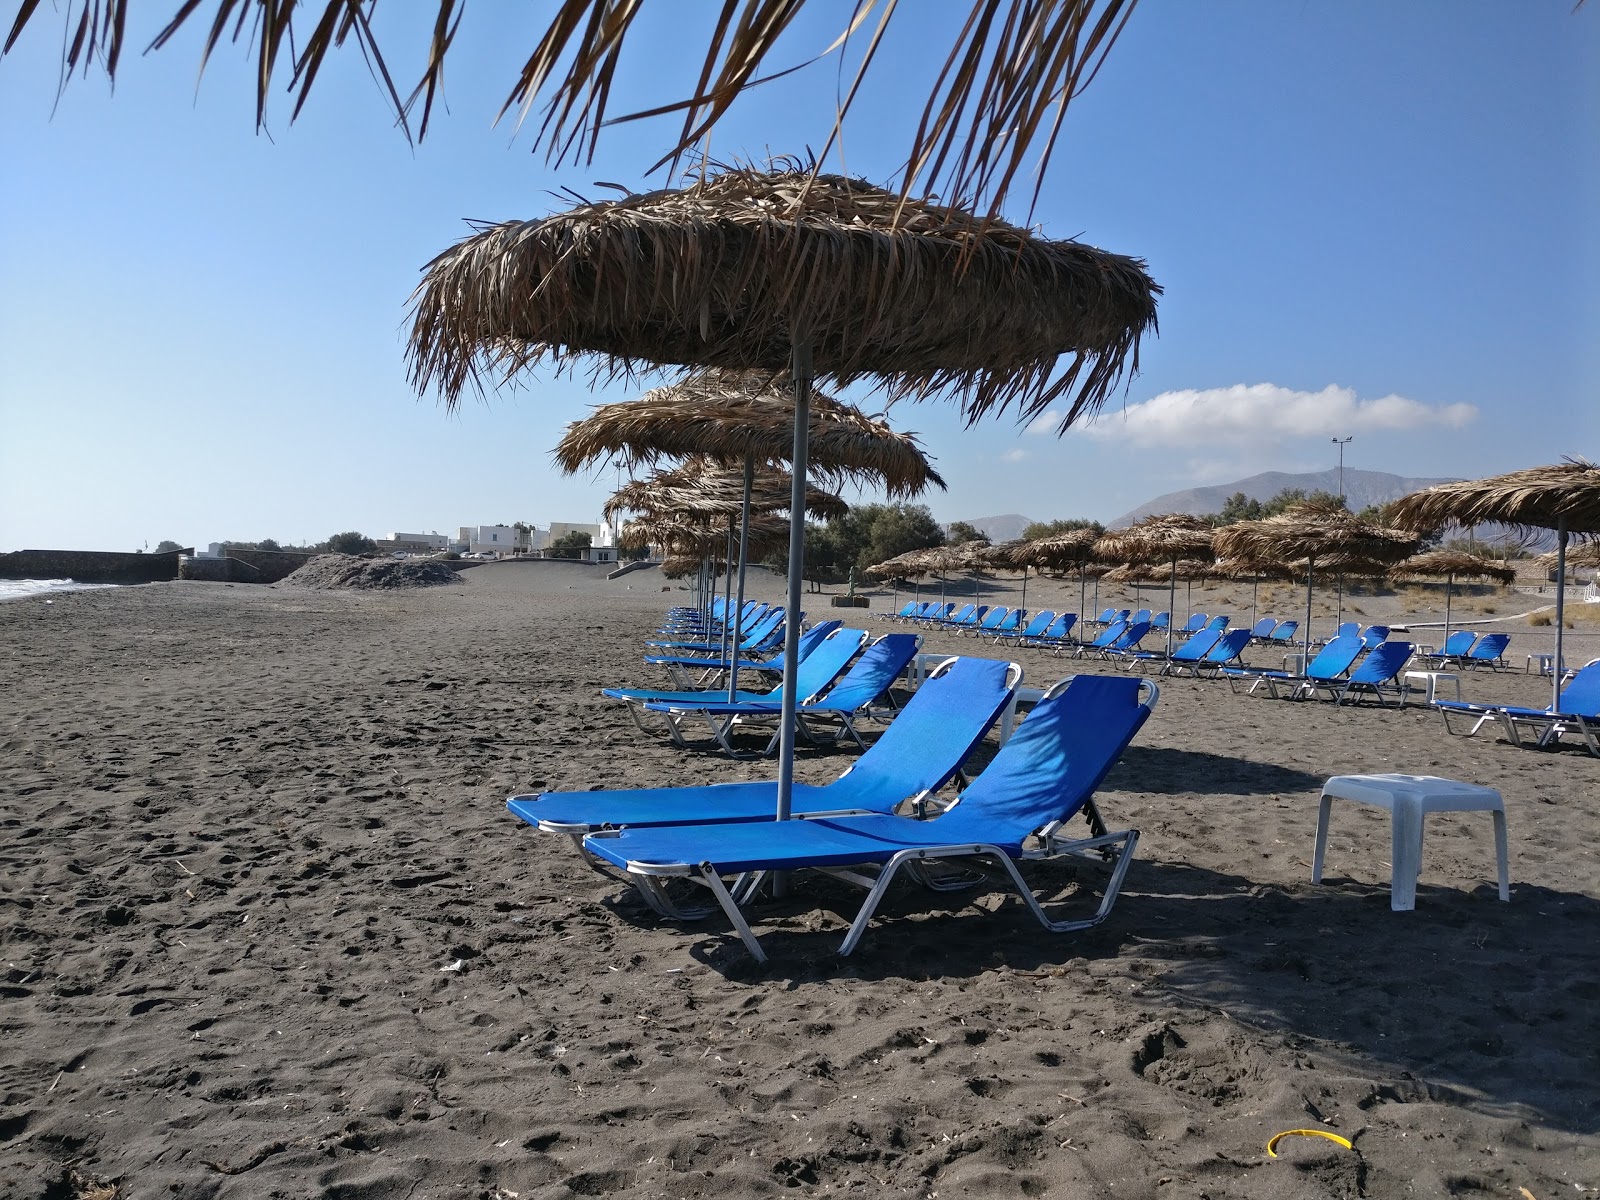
[410,163,1160,429]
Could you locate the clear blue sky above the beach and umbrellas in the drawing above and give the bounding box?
[0,0,1600,550]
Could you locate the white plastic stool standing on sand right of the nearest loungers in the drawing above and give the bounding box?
[1310,774,1510,912]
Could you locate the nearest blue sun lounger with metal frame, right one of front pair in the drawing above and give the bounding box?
[584,675,1157,962]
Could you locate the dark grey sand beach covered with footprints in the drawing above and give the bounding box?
[0,563,1600,1200]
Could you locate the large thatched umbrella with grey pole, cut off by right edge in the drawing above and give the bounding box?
[1389,458,1600,709]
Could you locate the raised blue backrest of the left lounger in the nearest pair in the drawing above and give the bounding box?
[829,656,1021,811]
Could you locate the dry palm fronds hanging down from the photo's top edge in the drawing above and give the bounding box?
[5,0,1134,208]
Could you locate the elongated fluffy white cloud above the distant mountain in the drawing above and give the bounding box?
[1075,384,1478,446]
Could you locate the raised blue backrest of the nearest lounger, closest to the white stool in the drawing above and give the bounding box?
[934,675,1150,845]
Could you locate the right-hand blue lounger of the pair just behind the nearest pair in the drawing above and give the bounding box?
[645,634,922,755]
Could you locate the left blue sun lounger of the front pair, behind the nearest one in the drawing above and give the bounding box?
[506,658,1022,850]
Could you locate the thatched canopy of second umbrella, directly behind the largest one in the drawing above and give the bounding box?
[555,370,944,499]
